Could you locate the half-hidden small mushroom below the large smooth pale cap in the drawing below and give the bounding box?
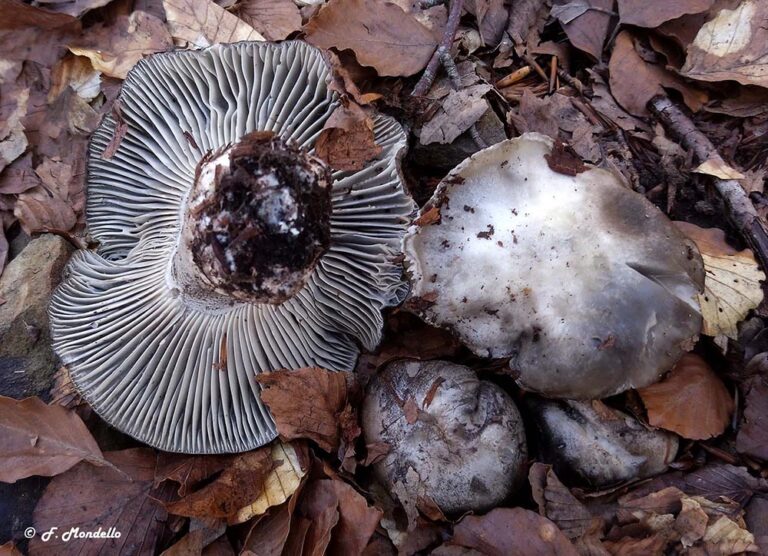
[528,399,678,487]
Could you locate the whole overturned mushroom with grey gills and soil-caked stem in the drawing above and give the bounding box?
[50,42,414,453]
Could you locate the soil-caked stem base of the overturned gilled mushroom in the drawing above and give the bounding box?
[187,132,331,304]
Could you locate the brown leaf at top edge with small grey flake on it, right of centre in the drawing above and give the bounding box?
[552,0,616,61]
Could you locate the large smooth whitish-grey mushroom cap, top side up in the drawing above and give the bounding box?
[403,137,703,399]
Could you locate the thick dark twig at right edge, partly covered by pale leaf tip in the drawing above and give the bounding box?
[648,95,768,270]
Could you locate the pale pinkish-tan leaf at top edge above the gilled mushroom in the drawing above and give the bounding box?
[163,0,264,48]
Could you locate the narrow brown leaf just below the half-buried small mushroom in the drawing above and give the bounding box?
[528,462,600,539]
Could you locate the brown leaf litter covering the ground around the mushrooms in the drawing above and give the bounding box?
[0,0,768,555]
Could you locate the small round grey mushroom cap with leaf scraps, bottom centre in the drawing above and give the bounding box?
[362,360,527,514]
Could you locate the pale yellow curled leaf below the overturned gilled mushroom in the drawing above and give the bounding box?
[230,442,307,523]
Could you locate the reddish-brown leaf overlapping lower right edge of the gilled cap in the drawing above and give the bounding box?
[256,367,347,454]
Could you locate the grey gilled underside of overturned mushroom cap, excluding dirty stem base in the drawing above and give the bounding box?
[50,42,414,453]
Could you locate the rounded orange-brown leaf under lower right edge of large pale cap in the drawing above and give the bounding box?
[638,353,734,440]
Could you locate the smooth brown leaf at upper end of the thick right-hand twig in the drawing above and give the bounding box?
[608,31,706,116]
